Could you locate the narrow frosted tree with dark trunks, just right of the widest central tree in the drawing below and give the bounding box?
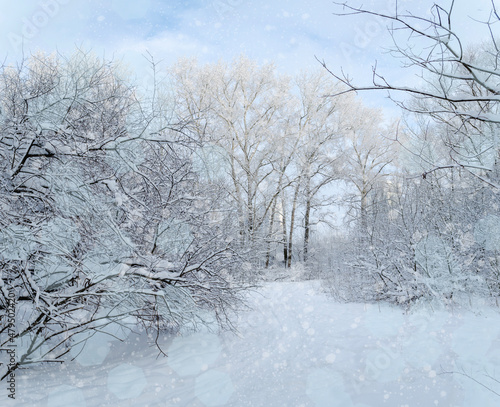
[288,71,346,266]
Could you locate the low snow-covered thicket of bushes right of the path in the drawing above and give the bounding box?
[330,171,500,305]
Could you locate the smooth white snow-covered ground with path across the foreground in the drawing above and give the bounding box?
[8,282,500,407]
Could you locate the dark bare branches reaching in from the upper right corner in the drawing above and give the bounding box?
[323,1,500,187]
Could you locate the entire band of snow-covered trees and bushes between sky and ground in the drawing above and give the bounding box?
[0,1,500,402]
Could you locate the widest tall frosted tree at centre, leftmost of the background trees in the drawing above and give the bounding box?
[171,57,289,262]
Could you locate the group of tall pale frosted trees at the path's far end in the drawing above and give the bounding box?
[170,57,395,267]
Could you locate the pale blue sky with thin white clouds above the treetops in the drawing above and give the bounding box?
[0,0,498,112]
